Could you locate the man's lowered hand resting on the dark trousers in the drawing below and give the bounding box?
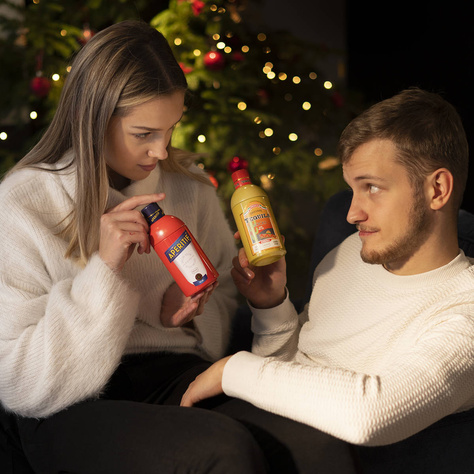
[181,356,232,407]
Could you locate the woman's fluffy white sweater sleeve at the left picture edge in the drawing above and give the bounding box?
[0,177,138,417]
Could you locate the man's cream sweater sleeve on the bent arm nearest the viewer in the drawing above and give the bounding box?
[222,305,474,445]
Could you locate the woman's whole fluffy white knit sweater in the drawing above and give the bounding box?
[0,157,237,417]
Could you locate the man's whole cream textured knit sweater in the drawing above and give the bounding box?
[223,234,474,445]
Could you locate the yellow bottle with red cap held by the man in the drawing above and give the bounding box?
[230,170,286,267]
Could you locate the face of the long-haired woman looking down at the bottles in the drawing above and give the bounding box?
[105,91,184,185]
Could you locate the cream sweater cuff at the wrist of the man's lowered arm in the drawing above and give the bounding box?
[222,351,264,399]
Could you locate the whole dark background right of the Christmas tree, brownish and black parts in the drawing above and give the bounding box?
[264,0,474,212]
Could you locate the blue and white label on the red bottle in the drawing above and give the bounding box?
[165,230,207,286]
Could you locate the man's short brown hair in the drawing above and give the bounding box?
[338,88,469,208]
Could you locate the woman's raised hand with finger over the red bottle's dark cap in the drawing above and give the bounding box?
[99,193,165,272]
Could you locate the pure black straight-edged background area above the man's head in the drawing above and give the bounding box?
[346,0,474,212]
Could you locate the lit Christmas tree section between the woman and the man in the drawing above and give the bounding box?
[151,0,354,296]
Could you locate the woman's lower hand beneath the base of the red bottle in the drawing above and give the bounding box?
[160,282,219,328]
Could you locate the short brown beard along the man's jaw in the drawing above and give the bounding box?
[360,187,431,265]
